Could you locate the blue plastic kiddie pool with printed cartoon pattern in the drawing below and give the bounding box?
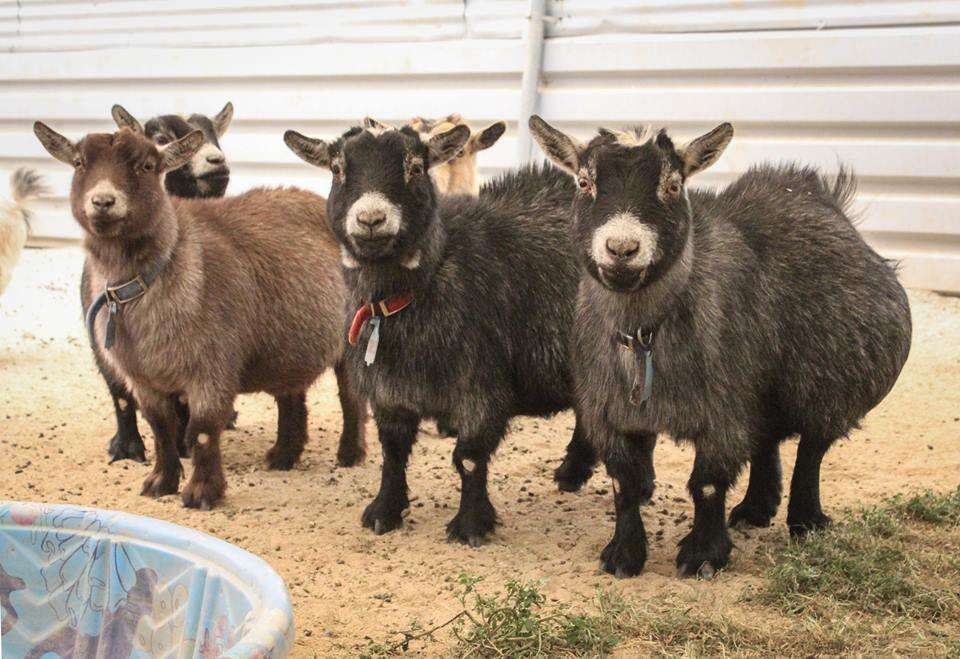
[0,502,294,659]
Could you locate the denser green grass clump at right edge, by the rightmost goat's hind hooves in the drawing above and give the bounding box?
[758,490,960,621]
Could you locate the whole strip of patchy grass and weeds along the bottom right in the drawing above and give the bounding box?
[364,488,960,657]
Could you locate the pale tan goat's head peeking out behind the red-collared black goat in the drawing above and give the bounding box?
[409,113,507,197]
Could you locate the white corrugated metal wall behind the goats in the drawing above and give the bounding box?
[0,0,960,290]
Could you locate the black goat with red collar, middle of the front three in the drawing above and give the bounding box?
[285,121,632,545]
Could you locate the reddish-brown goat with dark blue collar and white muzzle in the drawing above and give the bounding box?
[34,122,366,509]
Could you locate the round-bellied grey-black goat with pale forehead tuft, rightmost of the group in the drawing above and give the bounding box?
[530,117,911,576]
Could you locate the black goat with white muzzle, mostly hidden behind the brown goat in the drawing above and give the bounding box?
[80,102,236,462]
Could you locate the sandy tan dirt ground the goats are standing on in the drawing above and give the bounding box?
[0,248,960,657]
